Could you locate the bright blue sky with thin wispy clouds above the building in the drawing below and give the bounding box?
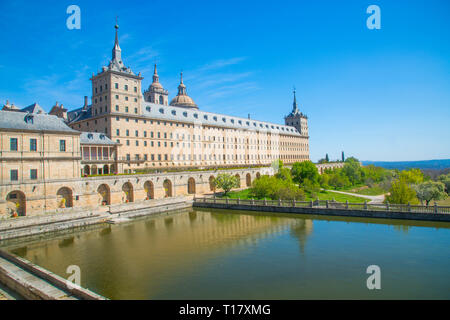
[0,0,450,161]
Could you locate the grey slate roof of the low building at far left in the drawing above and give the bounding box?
[0,111,79,134]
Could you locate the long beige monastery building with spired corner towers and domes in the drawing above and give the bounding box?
[68,26,309,173]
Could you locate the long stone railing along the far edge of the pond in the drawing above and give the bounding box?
[194,197,450,214]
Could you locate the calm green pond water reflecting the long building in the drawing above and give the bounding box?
[0,210,450,299]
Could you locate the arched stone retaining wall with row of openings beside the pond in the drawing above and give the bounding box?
[0,167,273,219]
